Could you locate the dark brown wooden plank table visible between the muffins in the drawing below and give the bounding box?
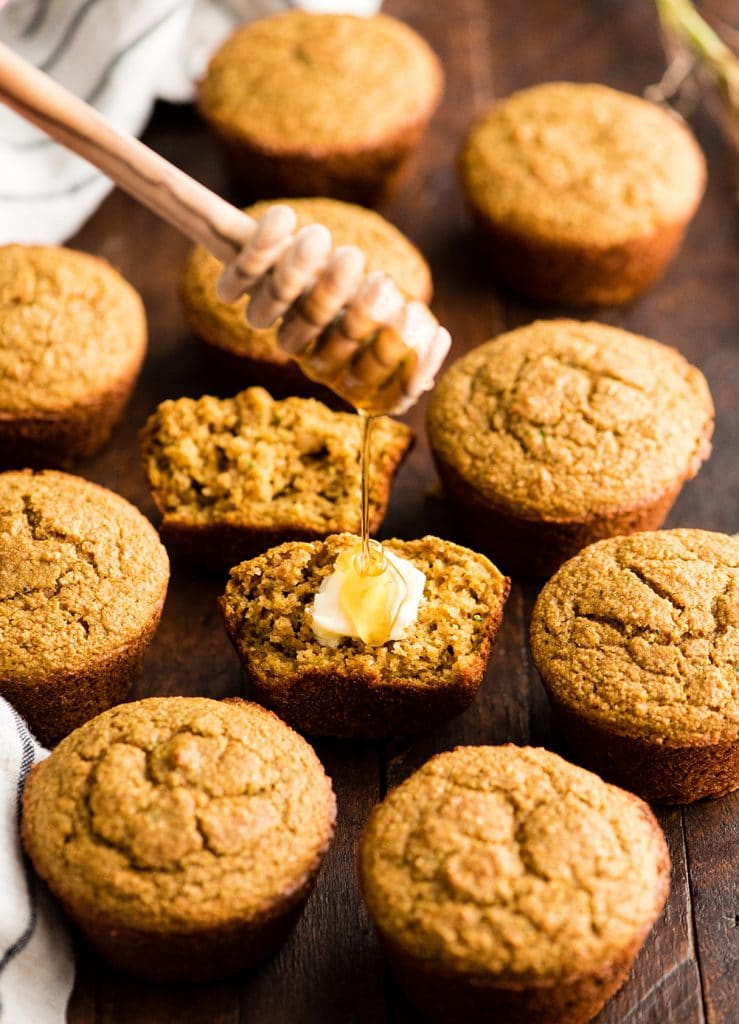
[61,0,739,1024]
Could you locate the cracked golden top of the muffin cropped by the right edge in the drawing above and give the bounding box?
[531,529,739,745]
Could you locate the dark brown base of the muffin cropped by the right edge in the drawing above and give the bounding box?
[542,700,739,804]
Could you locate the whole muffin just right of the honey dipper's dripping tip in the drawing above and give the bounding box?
[428,319,713,575]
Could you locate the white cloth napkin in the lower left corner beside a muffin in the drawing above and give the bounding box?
[0,697,75,1024]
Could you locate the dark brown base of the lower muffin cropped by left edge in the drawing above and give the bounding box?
[0,595,165,746]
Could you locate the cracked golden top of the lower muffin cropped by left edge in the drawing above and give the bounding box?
[0,470,169,682]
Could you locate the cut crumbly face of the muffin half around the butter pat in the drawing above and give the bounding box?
[221,534,508,686]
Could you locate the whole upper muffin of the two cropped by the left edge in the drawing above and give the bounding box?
[0,245,146,468]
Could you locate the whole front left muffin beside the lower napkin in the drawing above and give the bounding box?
[23,697,336,981]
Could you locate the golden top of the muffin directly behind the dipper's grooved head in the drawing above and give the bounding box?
[182,197,431,364]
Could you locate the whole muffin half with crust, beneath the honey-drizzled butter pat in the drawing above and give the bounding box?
[220,534,509,737]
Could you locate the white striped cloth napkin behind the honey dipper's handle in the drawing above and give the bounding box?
[0,0,382,244]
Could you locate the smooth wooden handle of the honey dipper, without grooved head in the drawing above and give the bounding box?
[0,43,255,263]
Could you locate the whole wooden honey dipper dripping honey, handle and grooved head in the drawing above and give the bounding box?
[0,44,450,414]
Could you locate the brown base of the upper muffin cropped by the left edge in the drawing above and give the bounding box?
[0,374,140,469]
